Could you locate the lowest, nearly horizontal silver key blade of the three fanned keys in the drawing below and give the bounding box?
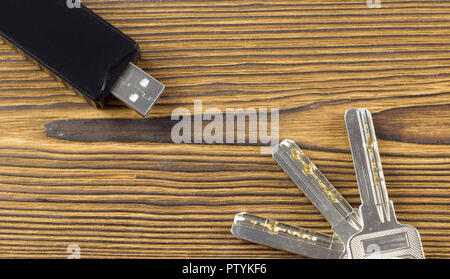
[231,212,345,259]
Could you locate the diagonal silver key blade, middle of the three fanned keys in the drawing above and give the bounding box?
[272,140,361,243]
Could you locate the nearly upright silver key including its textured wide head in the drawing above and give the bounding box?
[345,109,424,259]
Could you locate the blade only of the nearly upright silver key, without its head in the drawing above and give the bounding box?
[345,109,395,223]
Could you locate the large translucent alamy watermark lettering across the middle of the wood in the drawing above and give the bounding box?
[171,100,280,154]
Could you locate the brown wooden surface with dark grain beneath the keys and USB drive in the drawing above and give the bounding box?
[0,0,450,258]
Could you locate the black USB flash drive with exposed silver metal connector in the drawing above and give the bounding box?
[0,0,164,116]
